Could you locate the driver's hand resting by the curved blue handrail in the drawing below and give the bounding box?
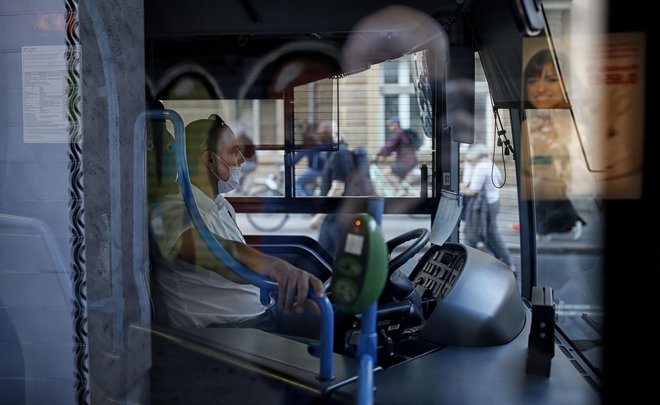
[268,258,324,316]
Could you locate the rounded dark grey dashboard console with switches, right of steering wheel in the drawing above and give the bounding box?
[410,243,525,346]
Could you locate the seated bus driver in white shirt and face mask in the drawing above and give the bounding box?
[149,115,323,339]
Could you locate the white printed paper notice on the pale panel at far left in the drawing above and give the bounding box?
[21,45,68,143]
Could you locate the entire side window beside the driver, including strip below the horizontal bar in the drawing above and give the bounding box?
[232,51,435,262]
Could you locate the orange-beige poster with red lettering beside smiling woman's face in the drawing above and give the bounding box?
[522,33,646,199]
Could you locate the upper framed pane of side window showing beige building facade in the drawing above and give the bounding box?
[293,52,433,197]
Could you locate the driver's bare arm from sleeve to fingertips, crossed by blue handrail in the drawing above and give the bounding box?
[174,229,324,311]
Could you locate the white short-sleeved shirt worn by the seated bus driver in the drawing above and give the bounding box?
[150,184,267,327]
